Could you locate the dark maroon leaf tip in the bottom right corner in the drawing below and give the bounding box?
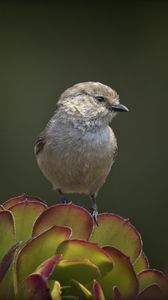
[136,284,167,300]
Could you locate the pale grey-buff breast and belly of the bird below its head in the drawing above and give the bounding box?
[39,127,117,194]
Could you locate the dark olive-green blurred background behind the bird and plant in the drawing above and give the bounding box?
[0,0,168,271]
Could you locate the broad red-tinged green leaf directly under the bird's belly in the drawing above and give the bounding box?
[33,203,93,240]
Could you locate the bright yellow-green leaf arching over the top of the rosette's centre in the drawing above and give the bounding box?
[57,240,113,274]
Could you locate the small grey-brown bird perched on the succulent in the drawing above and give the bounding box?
[35,82,128,222]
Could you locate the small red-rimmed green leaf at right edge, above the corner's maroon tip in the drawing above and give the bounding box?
[138,269,168,299]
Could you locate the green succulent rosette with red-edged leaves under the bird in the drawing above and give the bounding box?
[0,195,168,300]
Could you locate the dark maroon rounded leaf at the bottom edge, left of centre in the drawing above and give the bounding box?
[17,274,52,300]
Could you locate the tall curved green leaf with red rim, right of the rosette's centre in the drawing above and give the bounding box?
[99,246,138,300]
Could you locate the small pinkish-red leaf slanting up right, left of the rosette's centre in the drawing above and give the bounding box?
[35,255,61,279]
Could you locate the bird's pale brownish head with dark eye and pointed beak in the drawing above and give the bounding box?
[58,82,128,126]
